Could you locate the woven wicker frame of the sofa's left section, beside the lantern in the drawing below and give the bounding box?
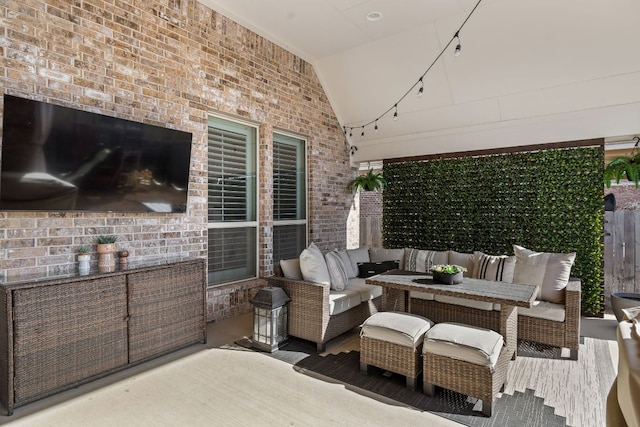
[267,276,382,352]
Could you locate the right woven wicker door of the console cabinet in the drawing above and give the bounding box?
[128,262,206,363]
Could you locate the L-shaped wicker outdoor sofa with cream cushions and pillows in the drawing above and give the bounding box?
[268,243,581,360]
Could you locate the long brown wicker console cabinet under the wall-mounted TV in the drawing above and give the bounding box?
[0,259,206,415]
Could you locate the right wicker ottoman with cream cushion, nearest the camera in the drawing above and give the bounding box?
[422,323,511,417]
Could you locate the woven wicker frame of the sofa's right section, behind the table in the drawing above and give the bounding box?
[408,278,581,360]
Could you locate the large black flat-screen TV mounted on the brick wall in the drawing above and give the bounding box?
[0,95,192,212]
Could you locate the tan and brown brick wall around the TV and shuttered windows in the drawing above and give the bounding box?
[0,0,355,320]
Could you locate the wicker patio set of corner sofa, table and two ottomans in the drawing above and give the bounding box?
[269,243,600,416]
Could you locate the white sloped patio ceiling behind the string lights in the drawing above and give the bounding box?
[199,0,640,162]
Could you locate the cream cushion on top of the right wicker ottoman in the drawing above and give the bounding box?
[422,323,504,367]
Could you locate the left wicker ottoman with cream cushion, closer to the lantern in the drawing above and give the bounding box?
[360,311,433,390]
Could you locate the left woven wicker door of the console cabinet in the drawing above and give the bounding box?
[13,275,127,404]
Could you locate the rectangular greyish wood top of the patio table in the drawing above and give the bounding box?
[366,270,538,307]
